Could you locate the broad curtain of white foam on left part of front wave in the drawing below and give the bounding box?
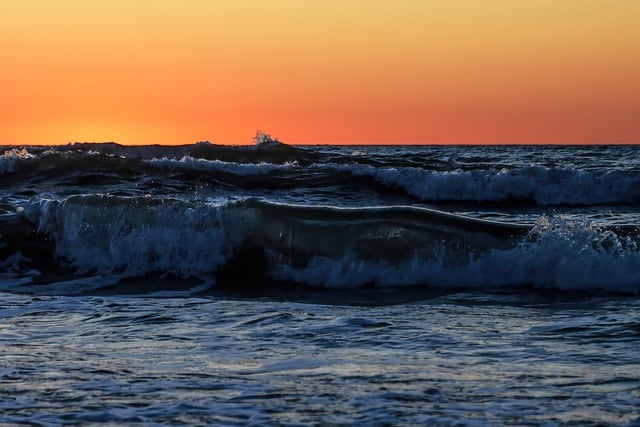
[28,196,250,277]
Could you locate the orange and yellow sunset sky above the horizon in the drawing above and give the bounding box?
[0,0,640,144]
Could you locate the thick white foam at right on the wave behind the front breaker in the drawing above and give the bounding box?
[342,165,640,205]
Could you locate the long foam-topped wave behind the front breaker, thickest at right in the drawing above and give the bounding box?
[147,157,640,206]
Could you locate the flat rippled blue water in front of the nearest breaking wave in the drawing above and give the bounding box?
[0,294,640,425]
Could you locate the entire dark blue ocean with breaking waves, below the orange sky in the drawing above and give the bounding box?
[0,139,640,426]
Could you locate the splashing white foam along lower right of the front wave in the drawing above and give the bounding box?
[274,217,640,294]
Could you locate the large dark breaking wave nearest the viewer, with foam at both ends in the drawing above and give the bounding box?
[0,195,640,294]
